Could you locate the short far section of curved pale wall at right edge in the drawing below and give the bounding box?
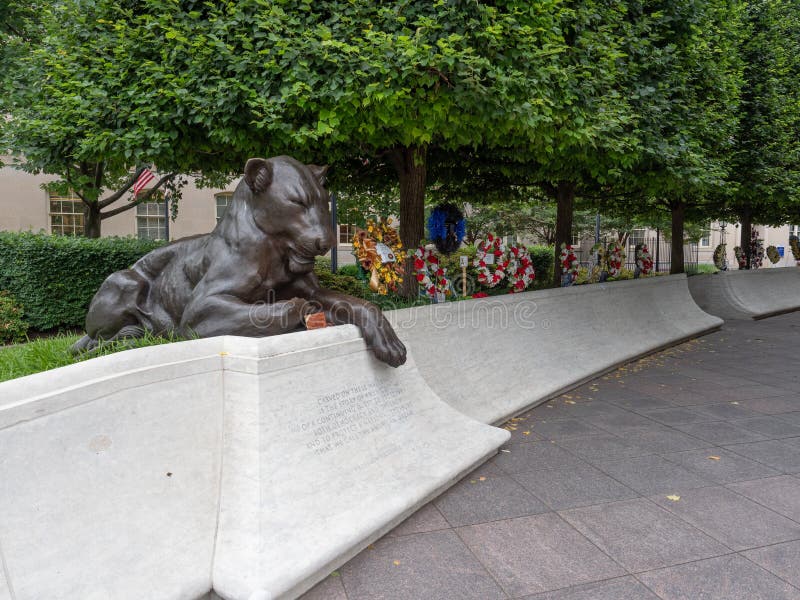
[689,267,800,319]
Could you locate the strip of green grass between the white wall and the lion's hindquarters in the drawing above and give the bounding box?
[0,334,180,381]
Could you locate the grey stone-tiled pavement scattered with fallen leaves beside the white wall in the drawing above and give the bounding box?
[296,313,800,600]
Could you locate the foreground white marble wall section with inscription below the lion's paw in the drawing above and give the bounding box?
[0,325,509,600]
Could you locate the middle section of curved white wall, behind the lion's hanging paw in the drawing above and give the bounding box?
[387,275,722,423]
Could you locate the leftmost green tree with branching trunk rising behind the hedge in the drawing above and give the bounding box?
[0,0,244,237]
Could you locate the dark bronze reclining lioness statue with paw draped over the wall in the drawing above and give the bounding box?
[72,156,406,367]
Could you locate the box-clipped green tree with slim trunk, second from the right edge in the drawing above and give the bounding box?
[617,0,742,273]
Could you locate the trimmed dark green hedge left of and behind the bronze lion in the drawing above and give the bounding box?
[0,232,165,331]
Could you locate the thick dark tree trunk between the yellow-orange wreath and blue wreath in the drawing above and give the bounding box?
[390,146,427,298]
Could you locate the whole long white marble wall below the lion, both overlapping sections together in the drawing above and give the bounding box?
[0,276,722,600]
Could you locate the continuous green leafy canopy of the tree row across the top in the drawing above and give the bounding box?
[0,0,800,280]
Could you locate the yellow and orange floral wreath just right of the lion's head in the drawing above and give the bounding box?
[353,217,403,296]
